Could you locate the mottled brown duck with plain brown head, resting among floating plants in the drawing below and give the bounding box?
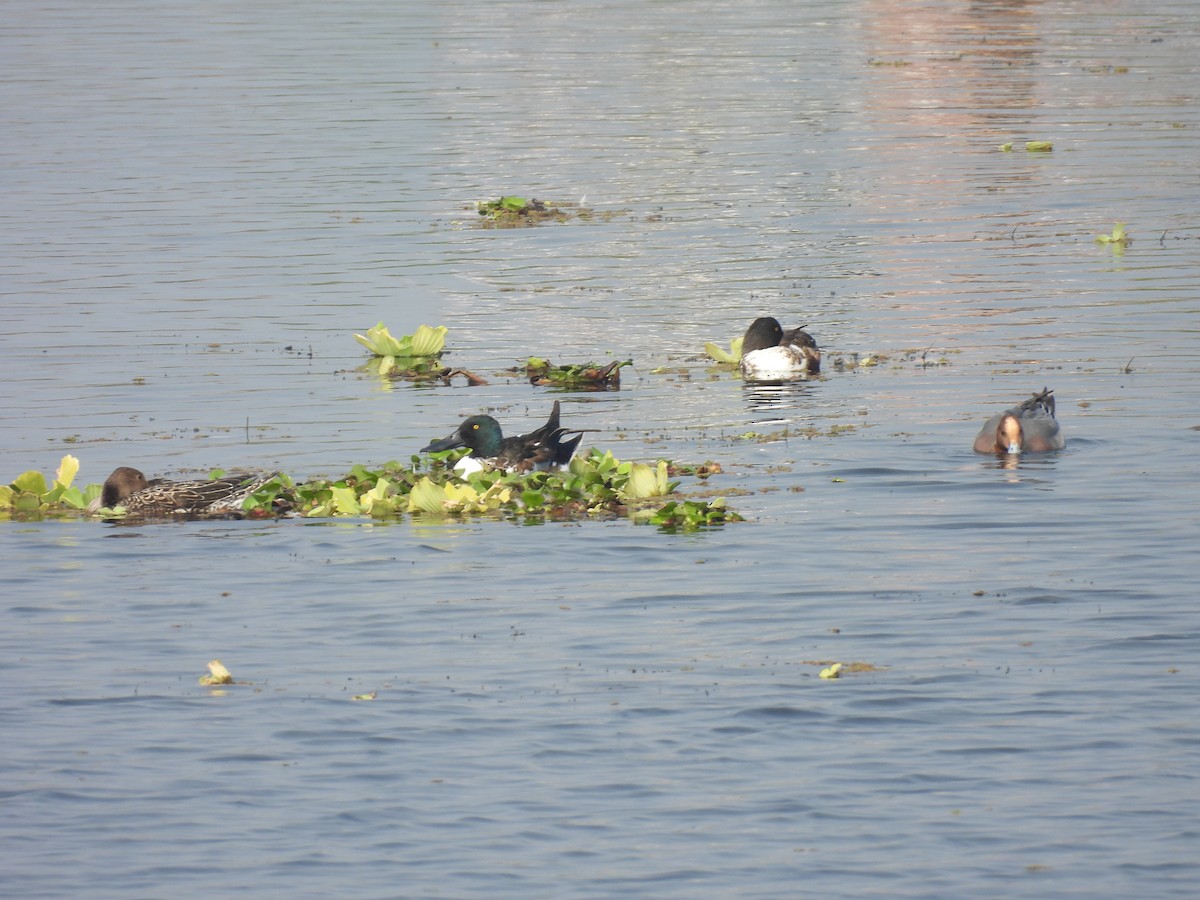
[88,466,280,516]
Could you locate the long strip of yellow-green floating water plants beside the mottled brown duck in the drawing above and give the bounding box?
[7,449,742,532]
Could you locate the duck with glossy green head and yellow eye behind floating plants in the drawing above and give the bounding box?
[421,400,588,474]
